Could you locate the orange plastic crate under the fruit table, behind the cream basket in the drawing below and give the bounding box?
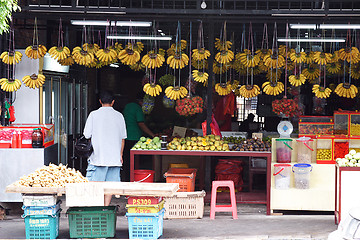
[164,168,197,192]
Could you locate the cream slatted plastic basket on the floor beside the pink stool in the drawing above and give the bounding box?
[164,191,206,219]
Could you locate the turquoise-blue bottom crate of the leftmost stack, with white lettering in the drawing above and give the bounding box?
[23,209,61,239]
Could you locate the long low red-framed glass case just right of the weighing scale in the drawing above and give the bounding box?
[299,122,334,137]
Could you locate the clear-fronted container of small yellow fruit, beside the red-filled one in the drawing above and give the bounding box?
[316,137,335,164]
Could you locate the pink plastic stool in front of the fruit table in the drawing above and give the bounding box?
[210,181,238,219]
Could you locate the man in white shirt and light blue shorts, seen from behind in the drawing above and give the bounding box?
[84,91,127,206]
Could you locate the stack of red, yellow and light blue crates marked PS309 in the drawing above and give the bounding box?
[126,196,165,239]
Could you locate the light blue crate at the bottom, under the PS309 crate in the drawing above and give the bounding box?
[126,208,165,239]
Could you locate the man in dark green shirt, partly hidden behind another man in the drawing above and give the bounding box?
[121,96,155,182]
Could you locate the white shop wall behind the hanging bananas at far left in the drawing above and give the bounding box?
[13,50,40,123]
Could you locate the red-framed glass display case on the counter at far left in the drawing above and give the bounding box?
[0,124,54,148]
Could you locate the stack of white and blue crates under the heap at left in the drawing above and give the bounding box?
[22,195,61,239]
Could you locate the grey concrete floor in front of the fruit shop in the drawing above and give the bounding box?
[0,198,337,240]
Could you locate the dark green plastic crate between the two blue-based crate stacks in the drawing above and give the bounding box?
[67,206,116,238]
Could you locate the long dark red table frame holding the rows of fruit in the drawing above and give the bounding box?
[130,150,271,215]
